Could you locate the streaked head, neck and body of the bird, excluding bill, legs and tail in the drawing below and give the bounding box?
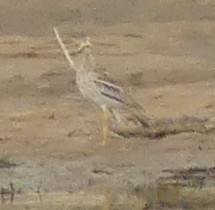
[75,39,125,109]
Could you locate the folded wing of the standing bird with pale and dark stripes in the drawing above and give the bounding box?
[94,69,126,104]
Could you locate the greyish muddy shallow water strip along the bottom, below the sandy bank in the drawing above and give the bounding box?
[1,159,215,209]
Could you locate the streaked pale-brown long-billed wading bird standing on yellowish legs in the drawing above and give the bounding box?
[54,28,149,145]
